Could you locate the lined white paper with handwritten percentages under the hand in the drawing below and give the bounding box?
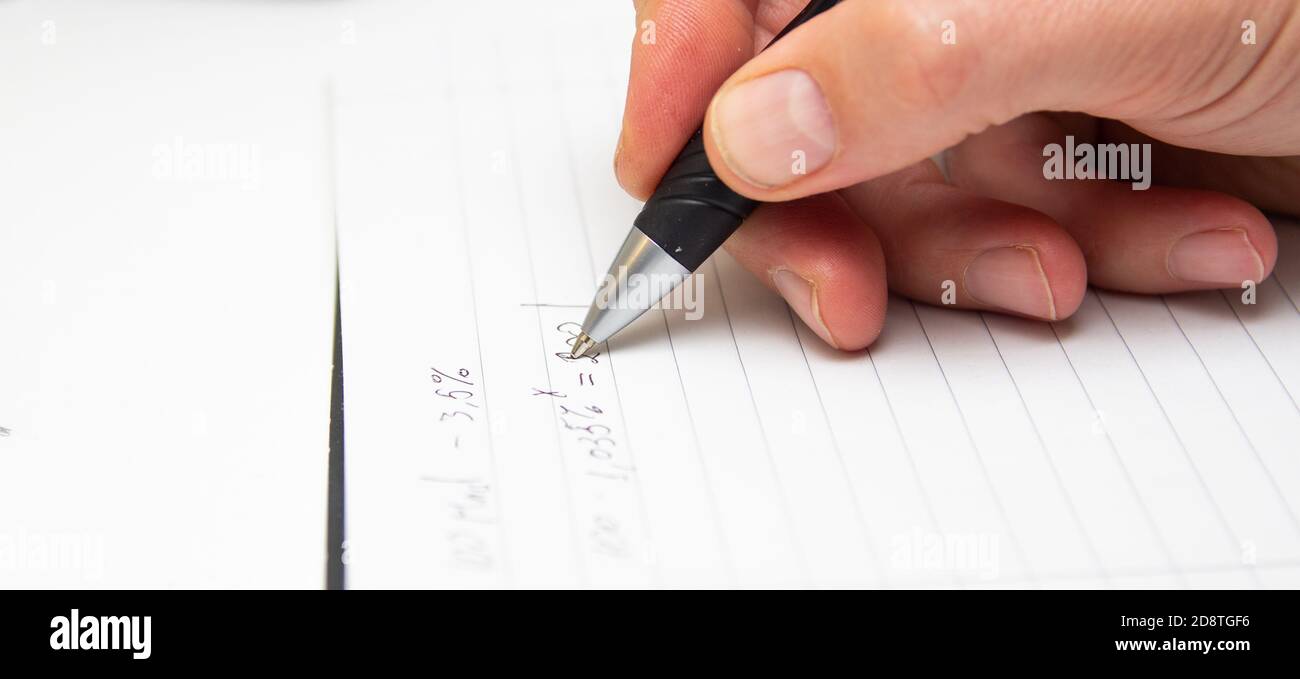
[338,36,1300,588]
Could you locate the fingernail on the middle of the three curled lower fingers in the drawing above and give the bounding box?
[963,246,1056,320]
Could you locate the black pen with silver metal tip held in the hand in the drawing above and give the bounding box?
[569,0,839,358]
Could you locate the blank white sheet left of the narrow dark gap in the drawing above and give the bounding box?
[0,71,335,588]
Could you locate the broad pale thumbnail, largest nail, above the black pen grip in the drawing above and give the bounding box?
[712,69,835,187]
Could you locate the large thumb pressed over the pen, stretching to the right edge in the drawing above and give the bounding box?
[705,0,1300,200]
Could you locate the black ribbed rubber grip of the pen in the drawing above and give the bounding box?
[634,130,758,271]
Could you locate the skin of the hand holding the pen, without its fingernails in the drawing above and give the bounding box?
[615,0,1300,350]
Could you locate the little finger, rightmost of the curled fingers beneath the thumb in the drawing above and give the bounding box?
[950,113,1278,292]
